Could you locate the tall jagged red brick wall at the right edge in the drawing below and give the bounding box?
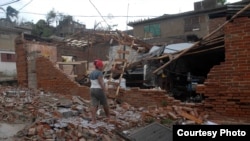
[197,17,250,121]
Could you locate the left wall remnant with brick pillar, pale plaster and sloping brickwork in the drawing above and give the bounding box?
[15,37,90,99]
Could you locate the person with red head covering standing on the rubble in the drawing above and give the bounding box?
[89,60,110,124]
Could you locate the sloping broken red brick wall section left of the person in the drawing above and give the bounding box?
[36,57,90,99]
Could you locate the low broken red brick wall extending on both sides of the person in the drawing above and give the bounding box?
[36,57,201,109]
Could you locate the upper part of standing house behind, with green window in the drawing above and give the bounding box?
[128,0,228,46]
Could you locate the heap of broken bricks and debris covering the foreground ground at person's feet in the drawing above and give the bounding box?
[0,86,213,141]
